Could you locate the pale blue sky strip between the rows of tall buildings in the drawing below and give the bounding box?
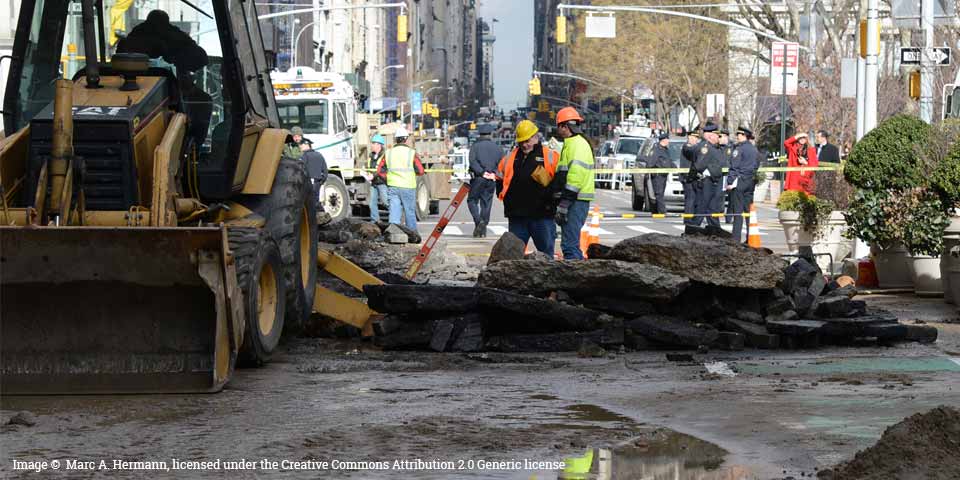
[480,0,533,109]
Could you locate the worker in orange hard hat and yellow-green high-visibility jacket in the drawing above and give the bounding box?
[551,107,594,260]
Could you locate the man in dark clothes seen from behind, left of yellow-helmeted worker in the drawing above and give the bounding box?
[467,123,503,238]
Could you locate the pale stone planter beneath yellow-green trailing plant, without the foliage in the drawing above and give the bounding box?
[779,211,853,272]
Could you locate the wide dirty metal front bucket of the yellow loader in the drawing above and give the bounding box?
[0,227,243,395]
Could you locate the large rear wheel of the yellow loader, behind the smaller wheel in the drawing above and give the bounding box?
[247,156,317,334]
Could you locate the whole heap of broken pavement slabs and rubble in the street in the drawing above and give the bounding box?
[364,233,937,352]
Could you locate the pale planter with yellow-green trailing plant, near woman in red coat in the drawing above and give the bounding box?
[777,190,848,270]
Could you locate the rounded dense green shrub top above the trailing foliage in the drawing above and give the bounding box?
[844,115,930,190]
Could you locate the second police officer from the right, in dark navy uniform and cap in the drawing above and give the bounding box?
[691,122,723,234]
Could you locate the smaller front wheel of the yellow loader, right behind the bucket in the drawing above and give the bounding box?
[227,227,286,367]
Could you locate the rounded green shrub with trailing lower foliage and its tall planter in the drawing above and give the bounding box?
[844,115,930,288]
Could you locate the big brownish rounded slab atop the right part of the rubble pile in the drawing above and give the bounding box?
[604,233,784,289]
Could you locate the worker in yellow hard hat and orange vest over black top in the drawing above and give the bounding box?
[497,120,560,258]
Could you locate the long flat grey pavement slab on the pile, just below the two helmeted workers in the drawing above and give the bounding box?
[477,260,690,301]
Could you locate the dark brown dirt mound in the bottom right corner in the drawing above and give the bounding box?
[818,406,960,480]
